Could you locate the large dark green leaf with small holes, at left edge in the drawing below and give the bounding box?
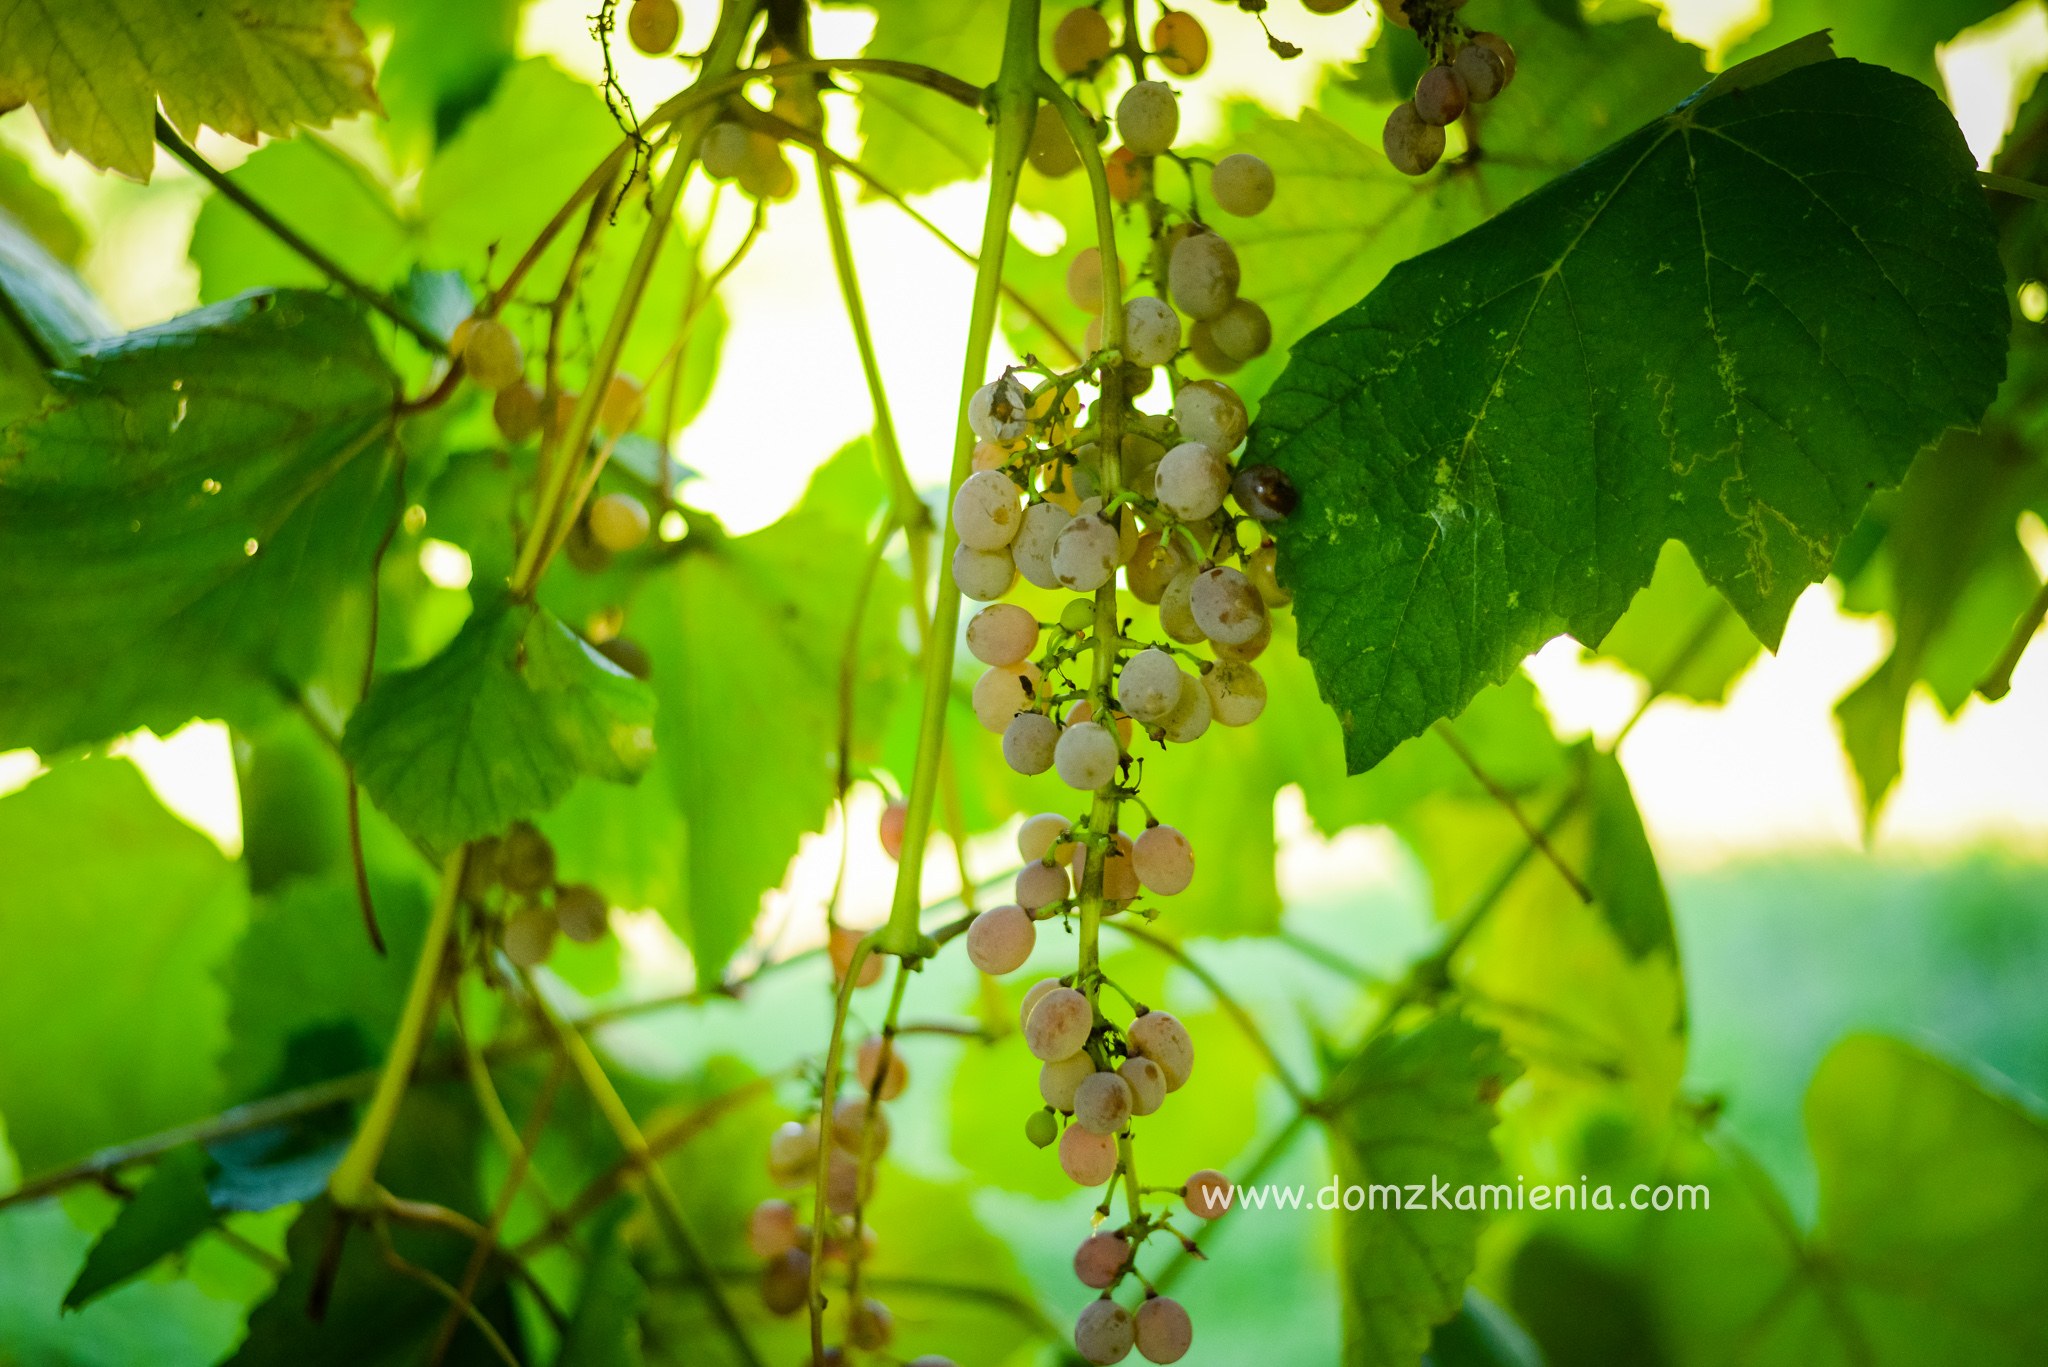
[0,291,395,752]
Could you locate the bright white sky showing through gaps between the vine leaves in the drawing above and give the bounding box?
[0,0,2048,889]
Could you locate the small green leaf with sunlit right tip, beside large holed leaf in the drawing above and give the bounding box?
[342,598,653,848]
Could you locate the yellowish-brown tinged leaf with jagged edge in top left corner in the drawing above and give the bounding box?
[0,0,379,180]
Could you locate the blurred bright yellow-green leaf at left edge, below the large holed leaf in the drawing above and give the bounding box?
[0,760,246,1172]
